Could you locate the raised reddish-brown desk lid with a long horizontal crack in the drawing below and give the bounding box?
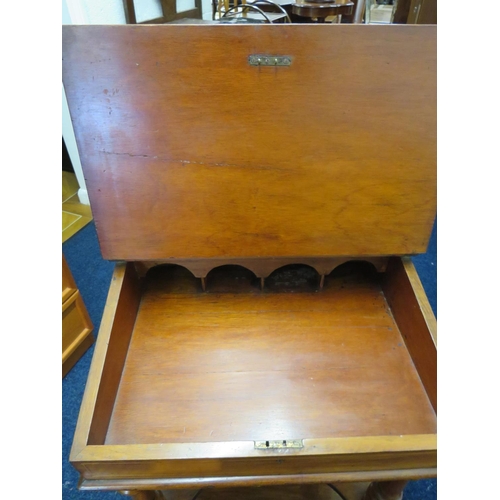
[63,25,436,260]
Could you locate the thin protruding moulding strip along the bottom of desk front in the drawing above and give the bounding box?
[79,468,437,491]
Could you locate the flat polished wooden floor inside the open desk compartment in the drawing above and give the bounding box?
[105,268,436,445]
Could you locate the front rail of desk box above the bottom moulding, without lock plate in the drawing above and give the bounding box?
[72,435,437,480]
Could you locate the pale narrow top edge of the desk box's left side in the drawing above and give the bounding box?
[70,263,136,460]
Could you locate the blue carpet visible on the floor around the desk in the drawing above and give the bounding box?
[62,222,437,500]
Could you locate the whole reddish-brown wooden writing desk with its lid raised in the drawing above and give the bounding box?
[63,25,437,499]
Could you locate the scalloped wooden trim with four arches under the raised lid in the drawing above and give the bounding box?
[135,255,389,278]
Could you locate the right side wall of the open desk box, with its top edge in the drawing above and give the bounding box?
[383,258,437,411]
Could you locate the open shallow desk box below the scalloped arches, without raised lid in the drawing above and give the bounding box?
[71,257,436,489]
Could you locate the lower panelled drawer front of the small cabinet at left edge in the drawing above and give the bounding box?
[62,291,93,376]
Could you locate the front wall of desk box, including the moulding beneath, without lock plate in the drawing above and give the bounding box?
[72,434,437,482]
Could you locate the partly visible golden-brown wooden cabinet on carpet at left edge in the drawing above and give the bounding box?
[62,255,94,377]
